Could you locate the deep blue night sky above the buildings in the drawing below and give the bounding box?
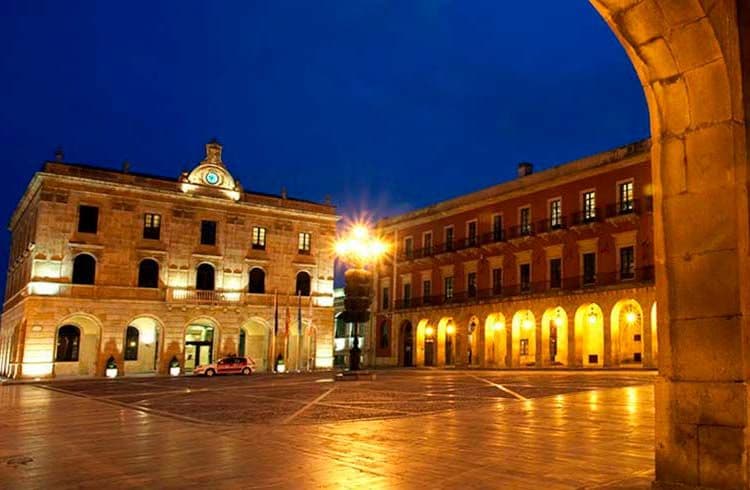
[0,0,648,288]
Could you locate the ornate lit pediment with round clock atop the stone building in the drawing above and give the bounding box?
[180,140,242,201]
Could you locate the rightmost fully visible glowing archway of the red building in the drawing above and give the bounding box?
[610,299,646,366]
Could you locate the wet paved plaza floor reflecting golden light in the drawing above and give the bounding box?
[0,370,654,488]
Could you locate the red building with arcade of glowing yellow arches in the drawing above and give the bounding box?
[370,141,657,367]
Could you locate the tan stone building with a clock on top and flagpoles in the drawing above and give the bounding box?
[0,141,338,378]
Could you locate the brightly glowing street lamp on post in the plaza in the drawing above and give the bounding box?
[334,223,388,371]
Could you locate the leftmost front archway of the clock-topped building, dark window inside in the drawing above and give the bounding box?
[54,313,102,376]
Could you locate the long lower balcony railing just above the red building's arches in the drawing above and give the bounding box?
[396,267,654,309]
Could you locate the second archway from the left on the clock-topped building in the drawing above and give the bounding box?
[123,316,164,374]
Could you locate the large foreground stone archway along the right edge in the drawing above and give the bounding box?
[591,0,750,488]
